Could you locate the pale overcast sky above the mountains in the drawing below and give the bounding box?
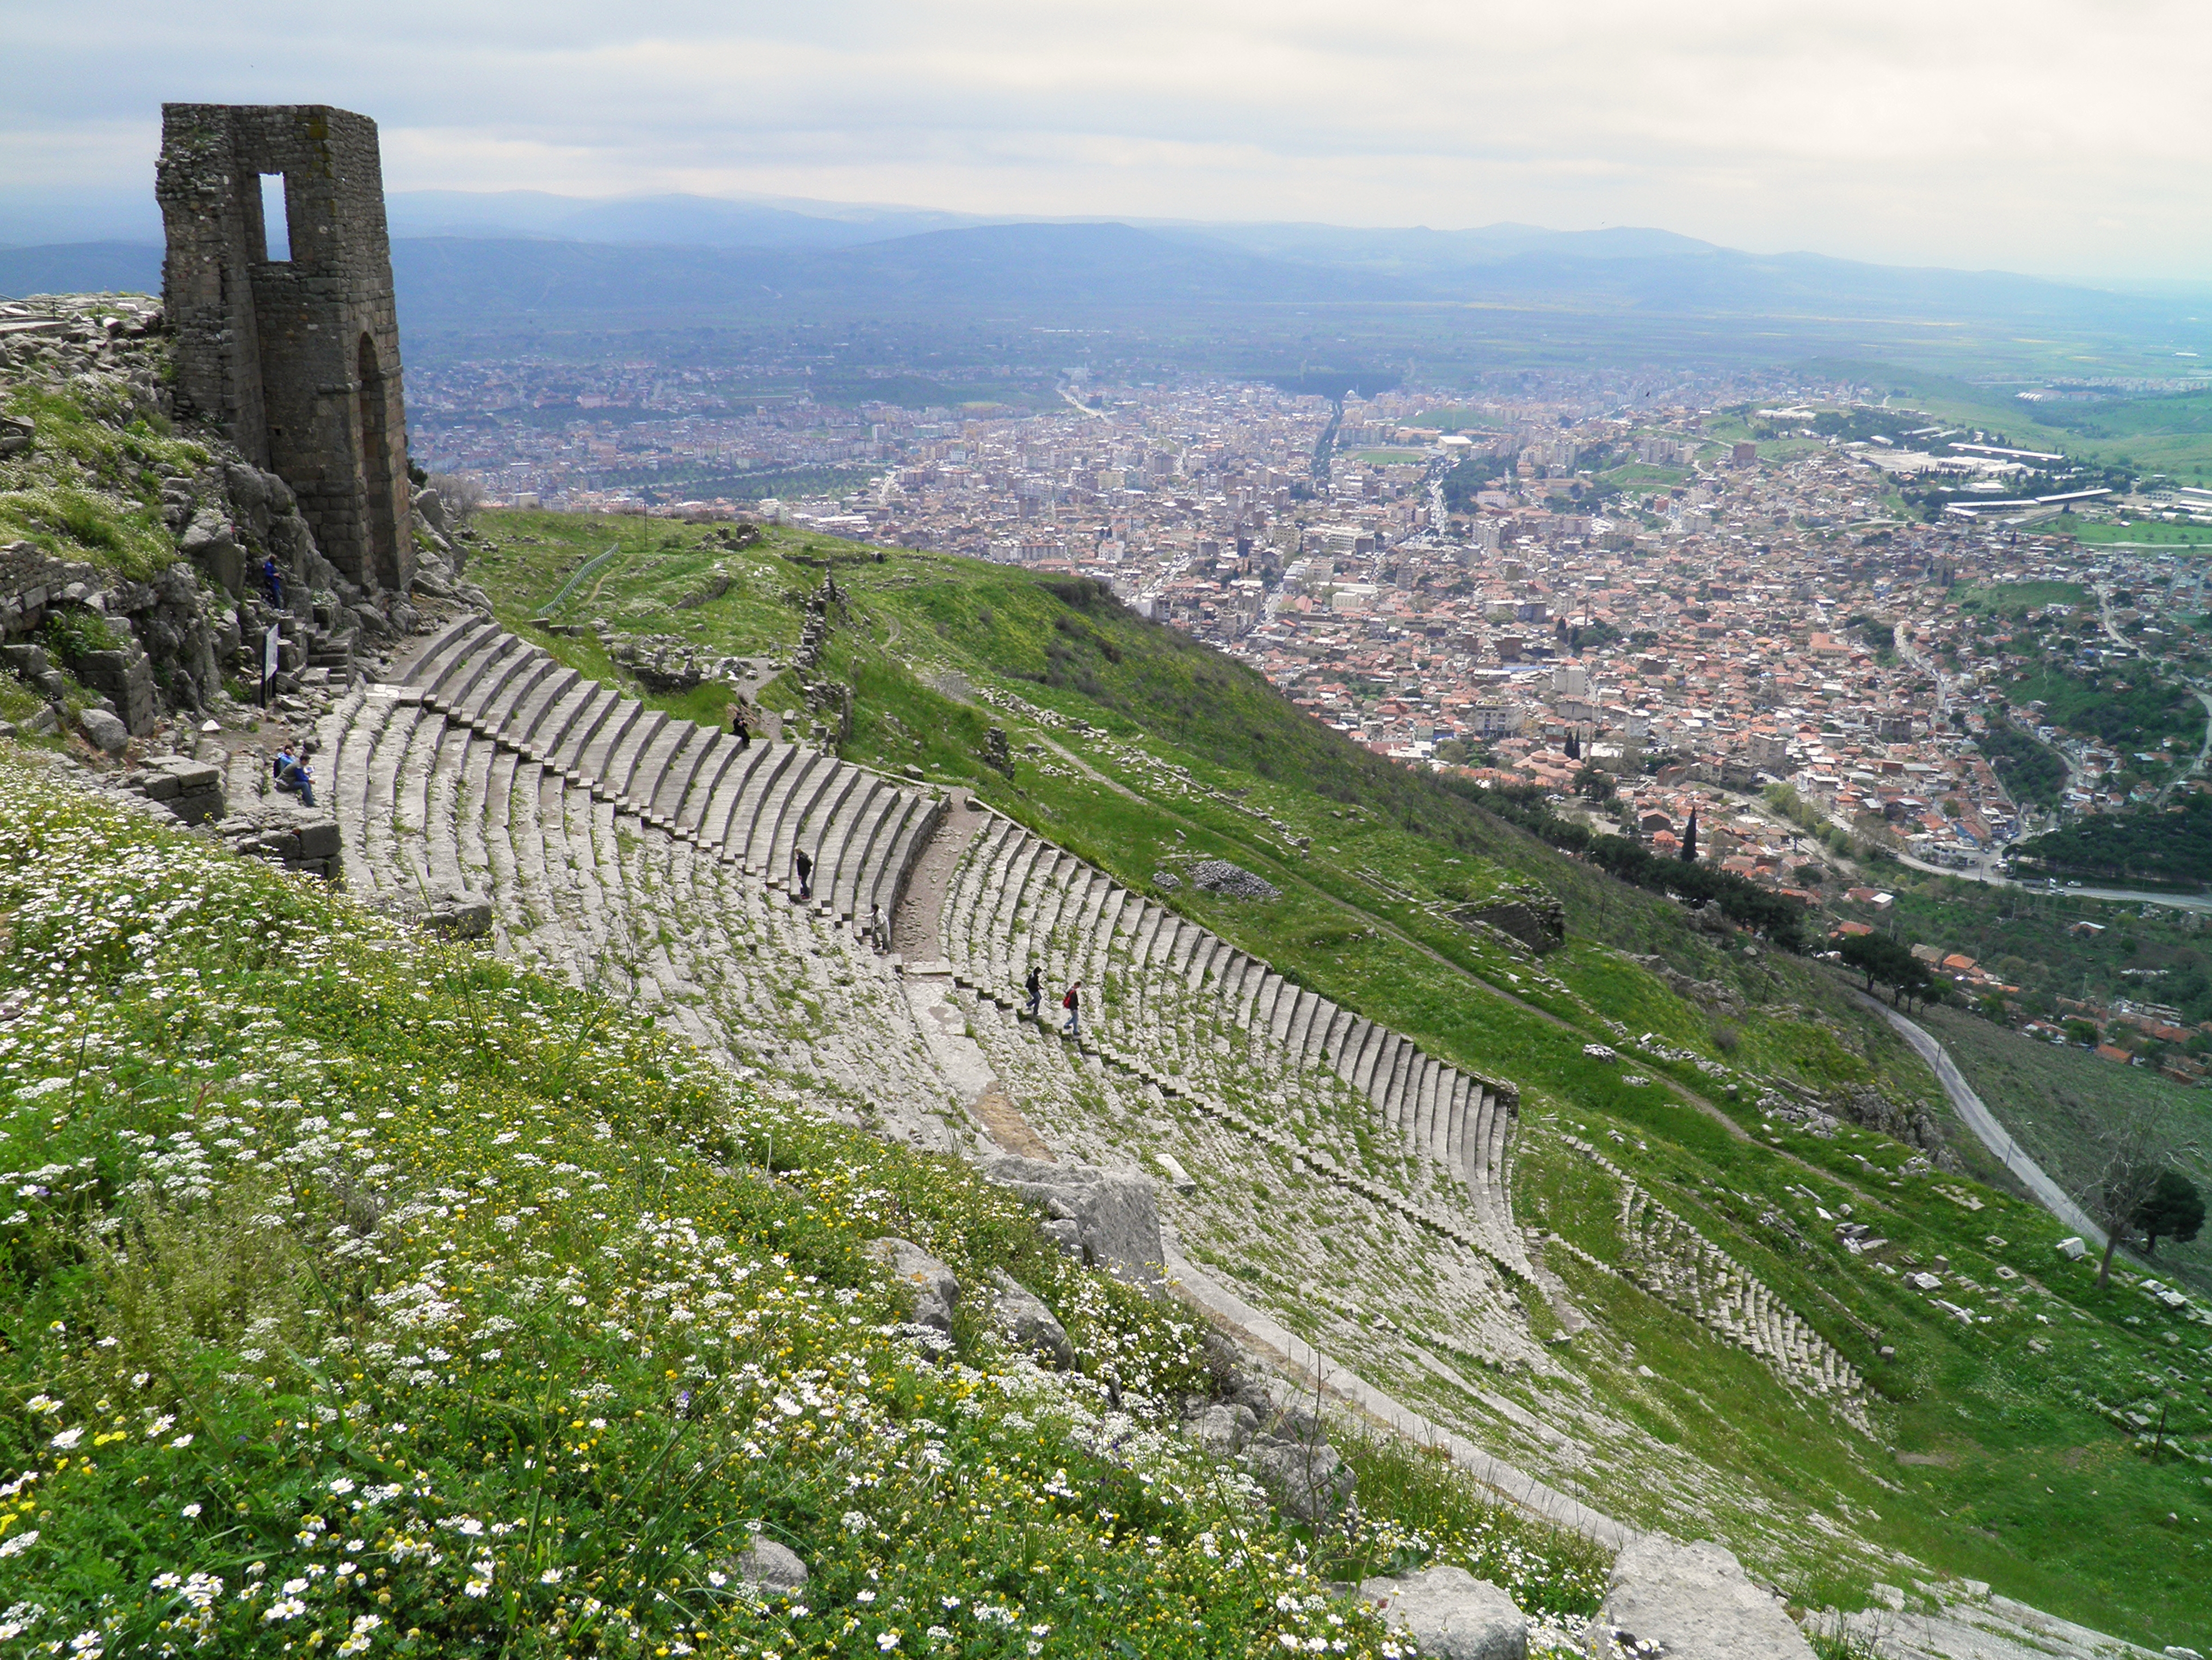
[0,0,2212,281]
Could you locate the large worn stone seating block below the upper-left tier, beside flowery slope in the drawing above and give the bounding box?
[323,686,960,1140]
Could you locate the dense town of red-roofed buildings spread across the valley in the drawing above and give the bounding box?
[418,367,2212,896]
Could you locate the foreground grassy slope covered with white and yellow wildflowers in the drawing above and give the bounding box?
[0,759,1601,1656]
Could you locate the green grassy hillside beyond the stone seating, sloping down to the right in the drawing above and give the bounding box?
[445,516,2212,1642]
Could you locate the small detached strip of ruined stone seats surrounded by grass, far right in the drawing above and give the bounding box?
[1562,1135,1874,1436]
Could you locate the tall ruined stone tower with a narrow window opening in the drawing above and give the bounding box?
[155,104,414,589]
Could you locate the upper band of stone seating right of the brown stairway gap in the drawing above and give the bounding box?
[940,815,1526,1266]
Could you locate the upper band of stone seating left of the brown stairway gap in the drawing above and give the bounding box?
[403,618,945,938]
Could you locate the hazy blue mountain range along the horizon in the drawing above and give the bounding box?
[0,190,2212,350]
